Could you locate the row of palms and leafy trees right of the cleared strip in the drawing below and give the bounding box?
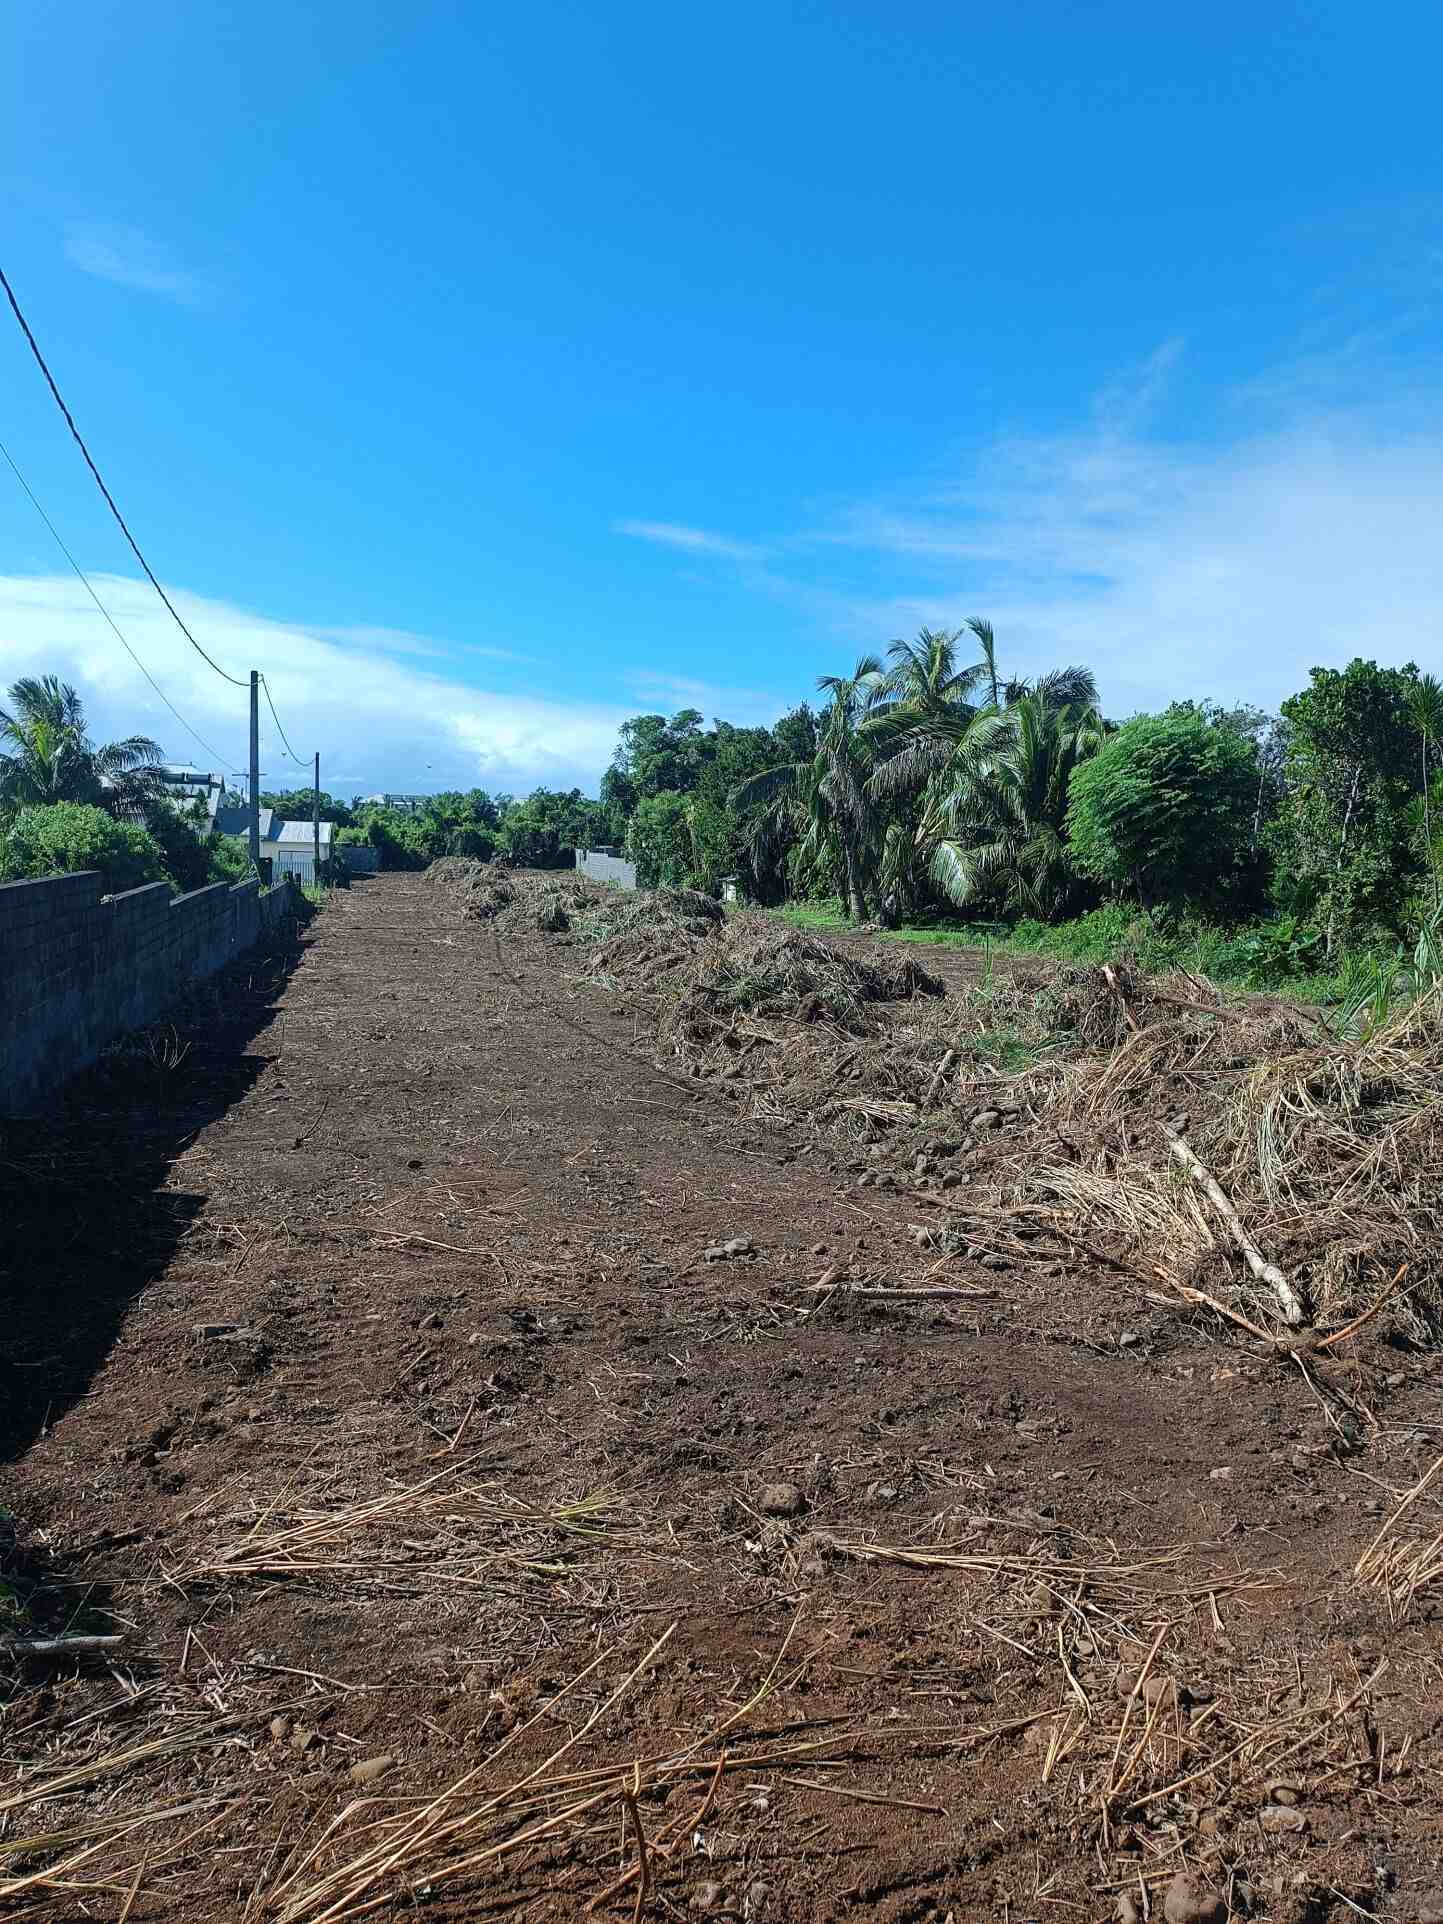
[600,620,1443,956]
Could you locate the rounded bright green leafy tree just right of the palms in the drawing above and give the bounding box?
[1068,706,1258,910]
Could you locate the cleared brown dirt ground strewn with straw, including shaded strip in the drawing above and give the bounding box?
[0,875,1443,1924]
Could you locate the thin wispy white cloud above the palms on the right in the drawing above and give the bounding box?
[661,339,1443,714]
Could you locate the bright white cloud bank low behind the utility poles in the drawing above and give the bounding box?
[0,575,629,793]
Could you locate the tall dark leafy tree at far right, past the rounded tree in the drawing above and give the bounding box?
[1270,660,1422,956]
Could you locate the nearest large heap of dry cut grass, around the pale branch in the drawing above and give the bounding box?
[1022,987,1443,1341]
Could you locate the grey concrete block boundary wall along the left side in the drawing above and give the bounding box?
[0,872,296,1116]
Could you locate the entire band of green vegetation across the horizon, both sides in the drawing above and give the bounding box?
[0,642,1443,987]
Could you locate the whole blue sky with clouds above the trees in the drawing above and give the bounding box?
[0,0,1443,789]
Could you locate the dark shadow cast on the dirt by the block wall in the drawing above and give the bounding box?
[0,908,313,1462]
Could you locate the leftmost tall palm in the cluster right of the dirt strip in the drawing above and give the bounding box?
[729,654,887,922]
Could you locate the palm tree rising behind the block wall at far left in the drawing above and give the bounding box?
[0,675,164,816]
